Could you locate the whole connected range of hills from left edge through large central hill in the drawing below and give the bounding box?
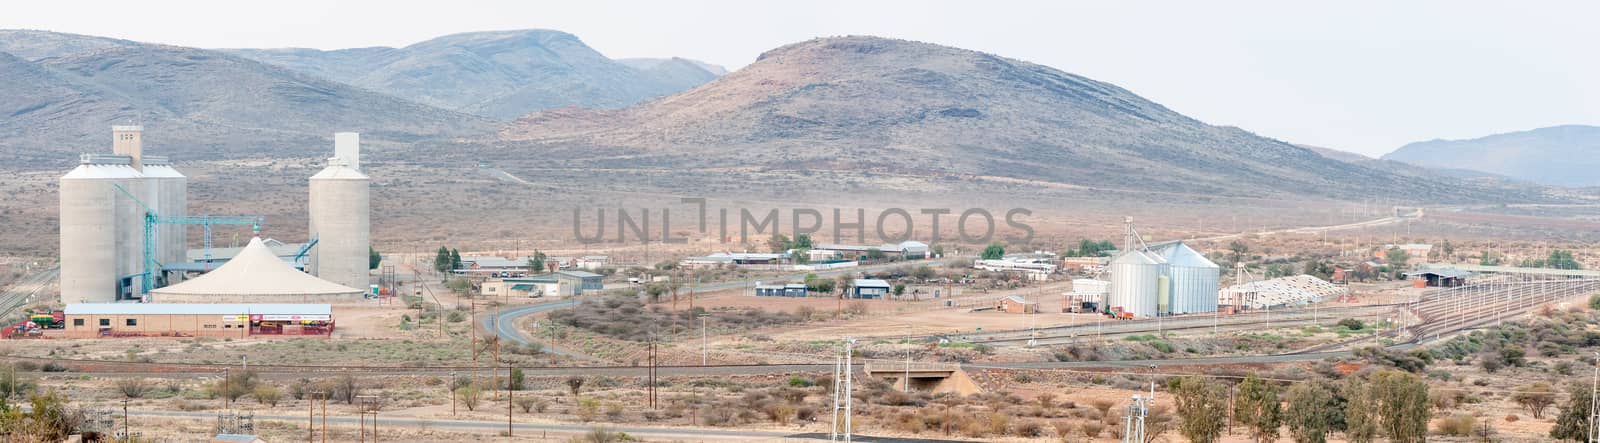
[0,30,1546,202]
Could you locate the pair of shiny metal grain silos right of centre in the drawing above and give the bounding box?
[1104,218,1221,318]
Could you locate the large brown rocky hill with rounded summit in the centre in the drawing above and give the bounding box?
[501,37,1536,200]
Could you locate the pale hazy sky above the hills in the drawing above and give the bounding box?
[0,0,1600,154]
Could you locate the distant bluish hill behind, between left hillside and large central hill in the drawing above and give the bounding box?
[227,30,717,120]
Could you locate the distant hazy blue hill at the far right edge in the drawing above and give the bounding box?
[1384,125,1600,187]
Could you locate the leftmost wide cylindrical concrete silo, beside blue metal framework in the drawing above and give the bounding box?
[61,154,144,302]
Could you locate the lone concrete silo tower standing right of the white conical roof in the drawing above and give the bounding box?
[307,133,371,288]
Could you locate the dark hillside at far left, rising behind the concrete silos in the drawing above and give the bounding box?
[0,34,491,165]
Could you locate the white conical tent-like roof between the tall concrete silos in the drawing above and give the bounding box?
[150,237,363,296]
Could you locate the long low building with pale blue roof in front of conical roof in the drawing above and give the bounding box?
[66,302,333,339]
